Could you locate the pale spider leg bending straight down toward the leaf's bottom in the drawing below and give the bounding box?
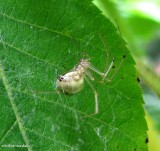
[84,76,98,117]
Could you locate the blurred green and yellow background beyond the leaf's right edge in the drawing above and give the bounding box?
[94,0,160,151]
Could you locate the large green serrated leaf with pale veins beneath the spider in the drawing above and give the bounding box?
[0,0,147,151]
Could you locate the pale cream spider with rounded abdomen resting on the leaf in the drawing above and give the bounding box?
[56,58,114,115]
